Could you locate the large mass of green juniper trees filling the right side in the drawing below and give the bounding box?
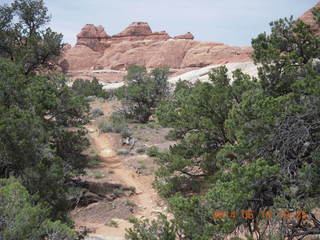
[148,6,320,239]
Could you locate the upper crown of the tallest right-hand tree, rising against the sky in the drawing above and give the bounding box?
[252,17,320,96]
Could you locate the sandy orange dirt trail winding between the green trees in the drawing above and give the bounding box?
[77,125,164,237]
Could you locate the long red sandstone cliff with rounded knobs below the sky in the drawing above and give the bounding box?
[62,22,252,74]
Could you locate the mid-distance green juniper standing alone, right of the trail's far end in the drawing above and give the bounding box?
[117,66,168,123]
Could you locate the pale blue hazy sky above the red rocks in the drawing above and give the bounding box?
[0,0,319,46]
